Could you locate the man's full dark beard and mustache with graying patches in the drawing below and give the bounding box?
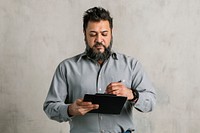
[85,39,112,62]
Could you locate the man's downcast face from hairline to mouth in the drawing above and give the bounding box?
[85,20,112,53]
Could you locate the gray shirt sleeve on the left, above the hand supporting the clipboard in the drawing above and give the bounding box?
[43,64,71,122]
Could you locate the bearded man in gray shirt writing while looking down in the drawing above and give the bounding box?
[44,7,155,133]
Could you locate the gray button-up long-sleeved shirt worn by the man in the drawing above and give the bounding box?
[44,53,155,133]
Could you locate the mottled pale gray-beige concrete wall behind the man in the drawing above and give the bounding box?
[0,0,200,133]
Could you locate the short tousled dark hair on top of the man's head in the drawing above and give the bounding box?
[83,7,113,32]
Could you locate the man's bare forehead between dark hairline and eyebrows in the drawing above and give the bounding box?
[86,20,111,31]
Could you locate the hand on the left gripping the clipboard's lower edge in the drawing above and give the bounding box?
[68,99,99,116]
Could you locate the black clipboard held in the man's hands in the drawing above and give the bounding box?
[83,93,127,114]
